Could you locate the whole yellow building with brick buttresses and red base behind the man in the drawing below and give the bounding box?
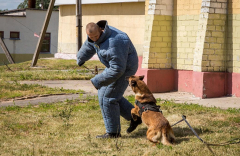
[56,0,240,98]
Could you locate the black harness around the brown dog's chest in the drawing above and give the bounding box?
[135,100,162,116]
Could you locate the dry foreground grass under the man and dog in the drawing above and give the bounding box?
[0,96,240,156]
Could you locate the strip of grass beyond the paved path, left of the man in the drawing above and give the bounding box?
[0,59,104,81]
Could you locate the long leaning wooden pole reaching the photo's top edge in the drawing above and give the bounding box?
[31,0,55,67]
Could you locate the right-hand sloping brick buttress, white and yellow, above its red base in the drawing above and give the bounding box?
[193,0,227,72]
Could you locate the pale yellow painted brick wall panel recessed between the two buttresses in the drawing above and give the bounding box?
[172,15,199,70]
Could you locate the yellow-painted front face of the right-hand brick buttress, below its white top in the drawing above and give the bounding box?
[202,13,227,72]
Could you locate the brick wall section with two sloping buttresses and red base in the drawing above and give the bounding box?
[137,0,240,98]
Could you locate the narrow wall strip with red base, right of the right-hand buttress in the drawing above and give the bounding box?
[227,0,240,97]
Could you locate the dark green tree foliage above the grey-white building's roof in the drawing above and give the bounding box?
[17,0,58,9]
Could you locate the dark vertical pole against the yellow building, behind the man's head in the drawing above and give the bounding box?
[76,0,82,52]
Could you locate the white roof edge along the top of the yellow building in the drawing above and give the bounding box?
[55,0,145,5]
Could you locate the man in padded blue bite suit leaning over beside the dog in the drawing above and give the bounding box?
[77,20,142,138]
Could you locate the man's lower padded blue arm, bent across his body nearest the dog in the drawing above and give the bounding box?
[91,39,130,89]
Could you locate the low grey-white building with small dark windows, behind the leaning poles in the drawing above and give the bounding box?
[0,8,59,64]
